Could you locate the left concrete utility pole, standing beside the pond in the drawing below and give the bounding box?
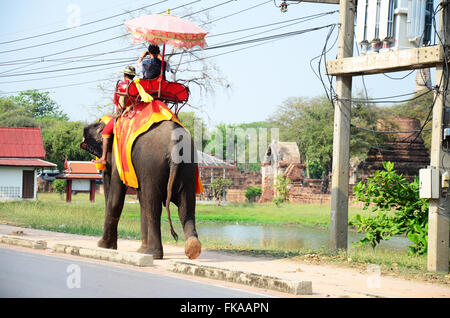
[330,0,355,252]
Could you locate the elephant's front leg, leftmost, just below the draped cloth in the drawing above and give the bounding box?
[97,169,127,249]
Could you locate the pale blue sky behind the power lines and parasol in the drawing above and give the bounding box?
[0,0,438,127]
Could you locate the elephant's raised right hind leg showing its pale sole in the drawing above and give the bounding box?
[178,185,202,259]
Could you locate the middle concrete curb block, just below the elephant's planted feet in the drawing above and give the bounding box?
[53,243,153,267]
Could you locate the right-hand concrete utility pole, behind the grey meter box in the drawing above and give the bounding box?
[427,2,450,272]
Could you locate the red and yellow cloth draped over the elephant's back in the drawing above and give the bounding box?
[113,100,203,193]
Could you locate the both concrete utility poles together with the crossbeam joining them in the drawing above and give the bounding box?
[290,0,450,272]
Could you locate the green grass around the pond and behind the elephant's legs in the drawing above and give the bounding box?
[0,193,450,284]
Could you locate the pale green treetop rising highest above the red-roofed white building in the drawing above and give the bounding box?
[11,89,69,120]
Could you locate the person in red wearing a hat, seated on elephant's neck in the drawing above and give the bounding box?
[92,65,136,165]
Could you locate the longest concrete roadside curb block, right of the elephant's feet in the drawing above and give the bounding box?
[167,261,312,295]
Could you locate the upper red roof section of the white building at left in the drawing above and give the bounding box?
[0,127,45,159]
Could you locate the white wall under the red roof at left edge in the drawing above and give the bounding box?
[0,167,37,201]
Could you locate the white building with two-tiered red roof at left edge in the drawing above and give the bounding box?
[0,127,56,201]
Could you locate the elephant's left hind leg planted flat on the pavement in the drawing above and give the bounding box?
[141,184,164,259]
